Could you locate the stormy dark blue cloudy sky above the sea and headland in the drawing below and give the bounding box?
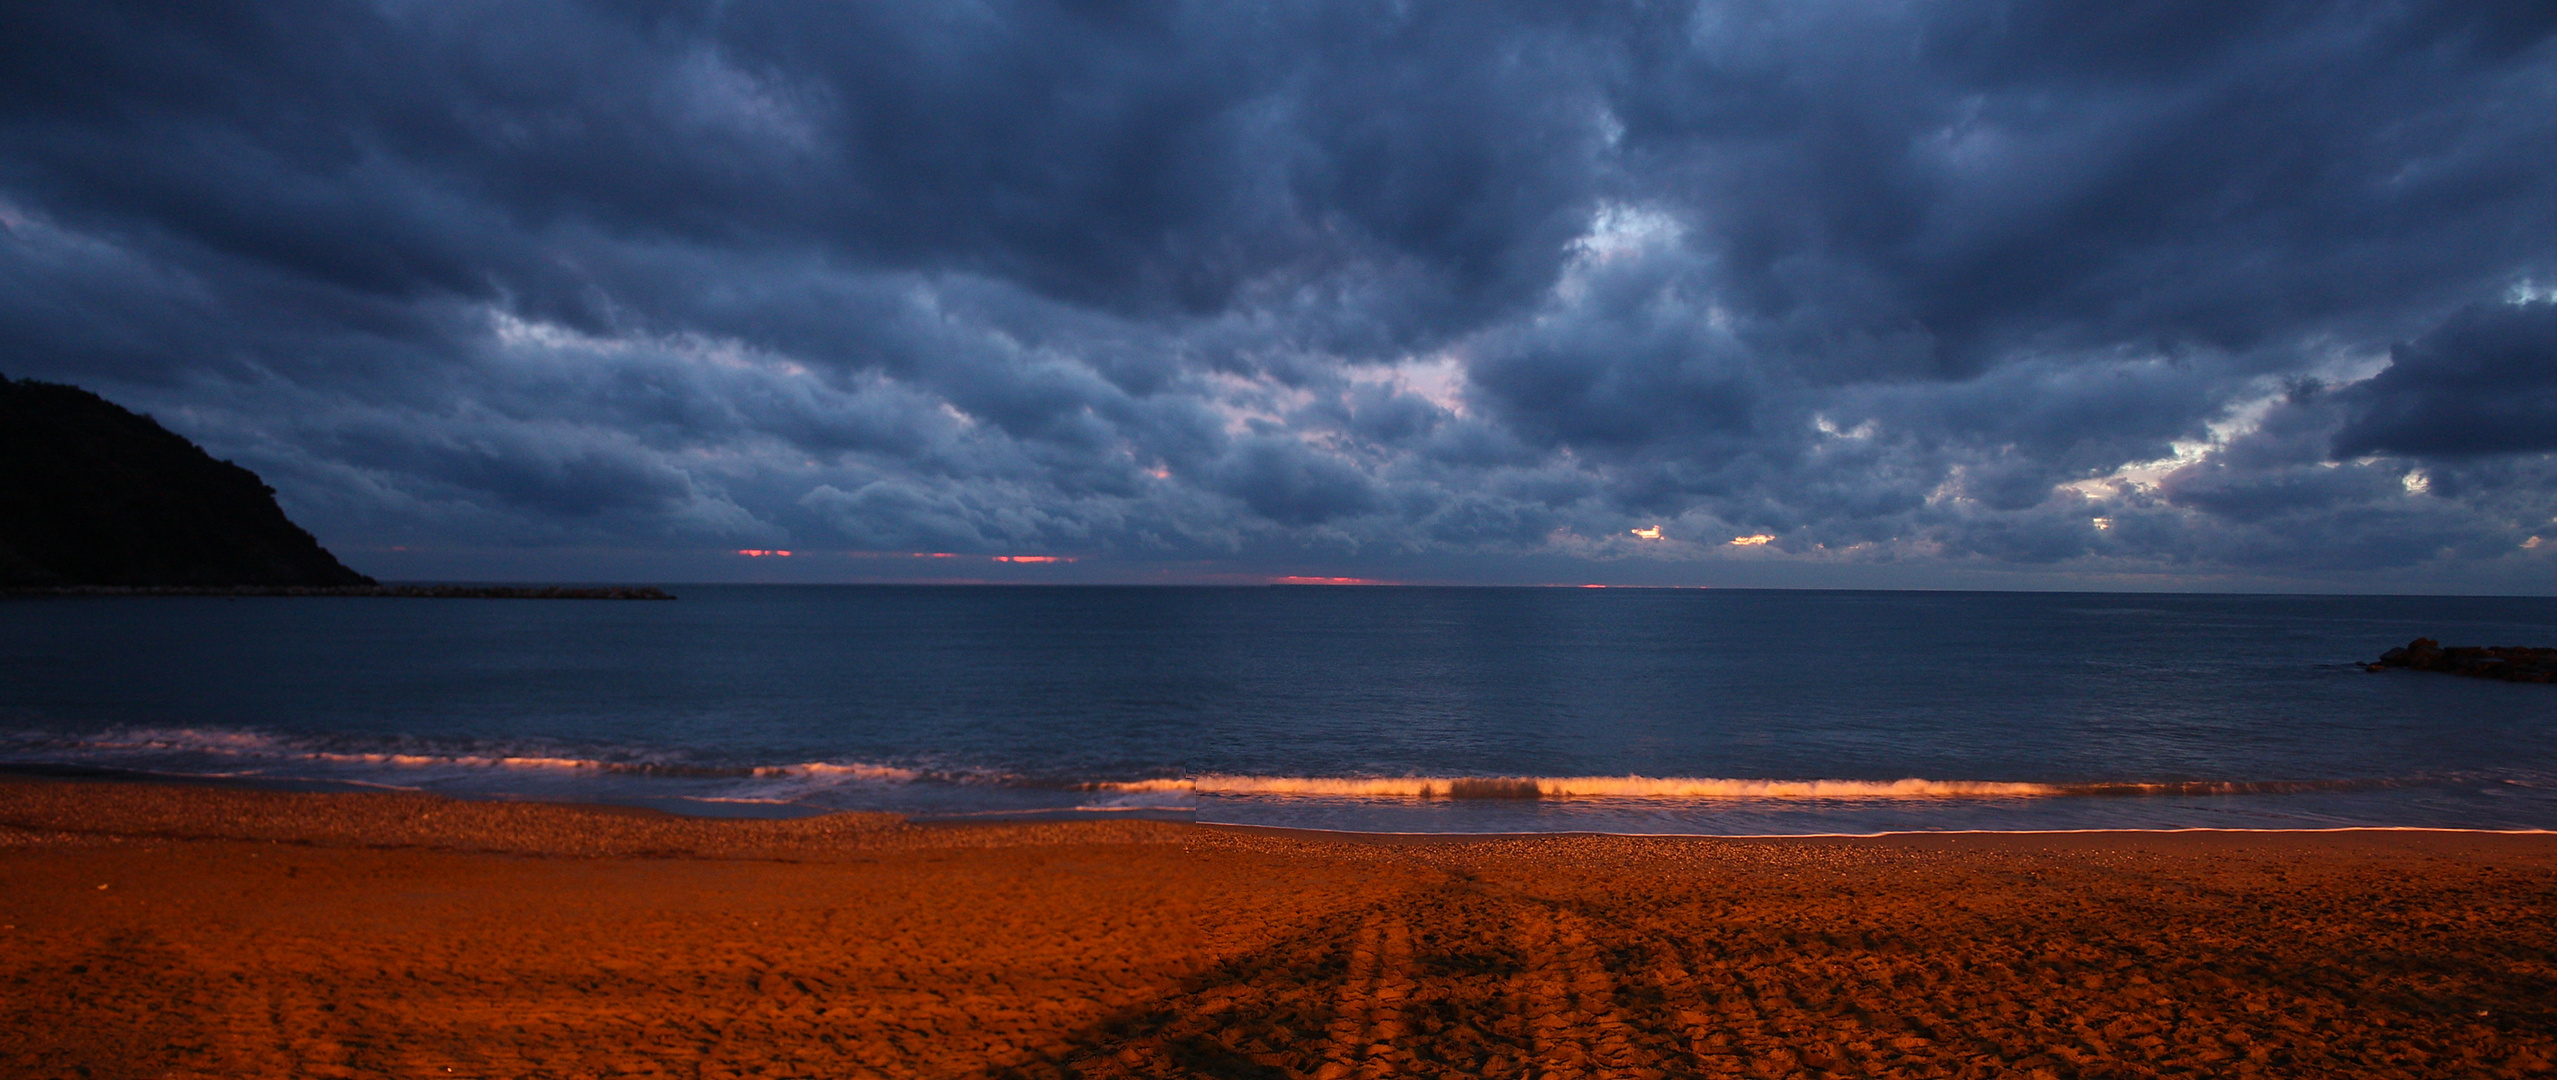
[0,0,2557,594]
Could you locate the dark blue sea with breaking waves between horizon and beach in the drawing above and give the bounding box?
[0,586,2557,834]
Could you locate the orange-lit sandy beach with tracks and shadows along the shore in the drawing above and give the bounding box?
[0,781,2557,1077]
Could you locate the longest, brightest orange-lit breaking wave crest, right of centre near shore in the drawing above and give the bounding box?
[1087,775,2386,798]
